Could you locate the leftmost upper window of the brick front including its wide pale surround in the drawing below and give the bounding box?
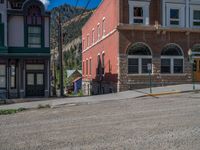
[129,0,150,25]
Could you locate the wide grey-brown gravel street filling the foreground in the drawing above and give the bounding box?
[0,93,200,150]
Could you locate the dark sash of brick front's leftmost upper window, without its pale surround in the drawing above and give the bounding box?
[133,7,144,24]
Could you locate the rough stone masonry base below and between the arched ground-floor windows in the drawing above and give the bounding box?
[118,54,192,92]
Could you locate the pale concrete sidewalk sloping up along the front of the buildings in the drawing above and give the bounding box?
[0,84,200,110]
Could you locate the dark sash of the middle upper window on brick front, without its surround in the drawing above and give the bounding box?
[170,9,180,26]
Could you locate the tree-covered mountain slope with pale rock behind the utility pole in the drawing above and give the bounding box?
[51,4,92,69]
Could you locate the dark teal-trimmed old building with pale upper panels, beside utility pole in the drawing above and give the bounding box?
[0,0,50,99]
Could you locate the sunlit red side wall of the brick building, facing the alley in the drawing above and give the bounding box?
[82,0,119,82]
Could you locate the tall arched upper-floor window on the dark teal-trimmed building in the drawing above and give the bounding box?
[27,5,42,48]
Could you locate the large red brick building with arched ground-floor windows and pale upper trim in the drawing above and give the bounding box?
[82,0,200,95]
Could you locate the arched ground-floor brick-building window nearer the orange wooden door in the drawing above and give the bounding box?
[161,44,184,74]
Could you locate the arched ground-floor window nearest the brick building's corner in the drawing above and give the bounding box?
[128,43,152,74]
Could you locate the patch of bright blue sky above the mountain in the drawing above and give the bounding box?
[46,0,102,10]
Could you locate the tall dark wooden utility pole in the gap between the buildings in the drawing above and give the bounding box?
[58,12,64,97]
